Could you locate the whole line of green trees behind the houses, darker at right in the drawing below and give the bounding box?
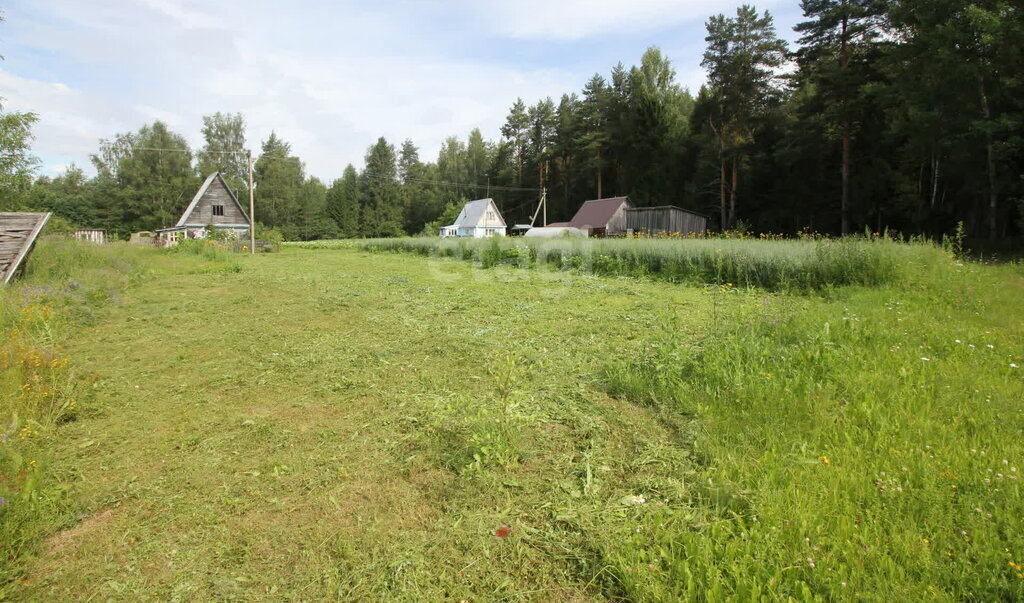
[0,0,1024,240]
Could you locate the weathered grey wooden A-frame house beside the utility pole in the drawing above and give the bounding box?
[157,172,251,246]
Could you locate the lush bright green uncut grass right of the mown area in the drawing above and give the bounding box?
[602,267,1024,601]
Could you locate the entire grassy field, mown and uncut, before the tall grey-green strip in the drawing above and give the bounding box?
[0,242,1024,601]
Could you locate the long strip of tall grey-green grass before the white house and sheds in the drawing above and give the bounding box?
[344,238,950,291]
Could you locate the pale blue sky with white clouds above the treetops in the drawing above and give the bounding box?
[0,0,801,182]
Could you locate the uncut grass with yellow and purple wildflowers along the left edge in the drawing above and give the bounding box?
[0,236,243,588]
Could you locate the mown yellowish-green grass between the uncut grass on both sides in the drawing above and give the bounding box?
[18,245,729,600]
